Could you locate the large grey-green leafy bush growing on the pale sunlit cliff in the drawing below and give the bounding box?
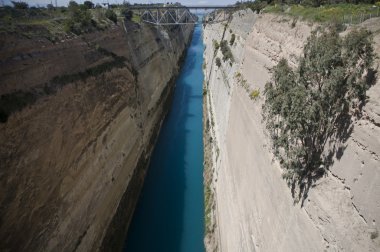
[263,27,374,200]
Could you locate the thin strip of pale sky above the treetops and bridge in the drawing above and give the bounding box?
[0,0,242,6]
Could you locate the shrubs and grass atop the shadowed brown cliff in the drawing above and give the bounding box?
[0,1,139,38]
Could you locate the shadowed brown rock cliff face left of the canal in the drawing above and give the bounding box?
[0,20,193,251]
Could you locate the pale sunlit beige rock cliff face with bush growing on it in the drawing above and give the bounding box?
[204,10,380,251]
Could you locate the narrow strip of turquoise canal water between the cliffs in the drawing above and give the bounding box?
[124,25,204,252]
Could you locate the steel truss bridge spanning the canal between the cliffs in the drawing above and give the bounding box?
[130,5,236,25]
